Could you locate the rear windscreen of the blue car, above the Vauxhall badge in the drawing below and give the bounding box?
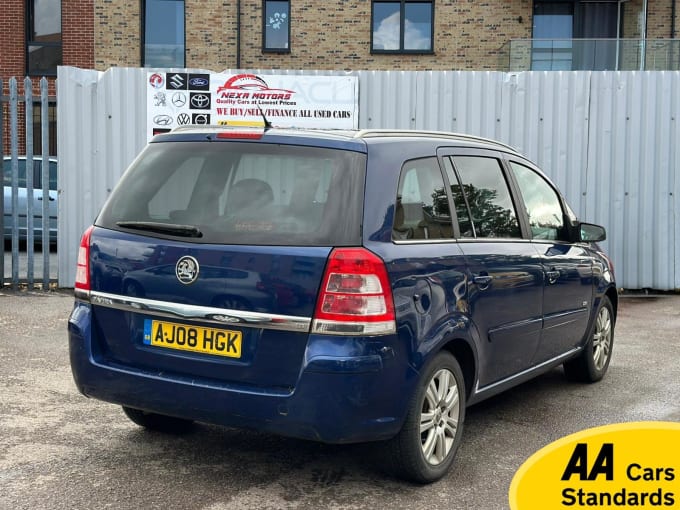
[96,142,366,246]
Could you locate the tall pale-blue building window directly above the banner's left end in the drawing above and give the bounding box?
[142,0,185,67]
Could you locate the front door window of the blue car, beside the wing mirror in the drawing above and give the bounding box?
[510,162,567,240]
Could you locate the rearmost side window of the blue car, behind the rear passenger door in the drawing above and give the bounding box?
[392,158,453,239]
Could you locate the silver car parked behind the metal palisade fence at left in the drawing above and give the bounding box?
[3,156,57,244]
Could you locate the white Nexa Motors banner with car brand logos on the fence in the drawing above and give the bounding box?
[147,72,359,140]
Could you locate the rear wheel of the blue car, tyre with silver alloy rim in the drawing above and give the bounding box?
[384,351,465,483]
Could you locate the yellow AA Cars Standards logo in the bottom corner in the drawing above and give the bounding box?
[509,422,680,510]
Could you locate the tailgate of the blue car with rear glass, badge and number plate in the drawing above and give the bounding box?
[90,141,365,392]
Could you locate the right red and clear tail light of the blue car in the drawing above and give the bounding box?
[312,248,396,335]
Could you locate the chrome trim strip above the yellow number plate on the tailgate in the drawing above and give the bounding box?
[83,291,312,333]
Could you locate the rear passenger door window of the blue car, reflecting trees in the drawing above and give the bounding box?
[453,156,522,237]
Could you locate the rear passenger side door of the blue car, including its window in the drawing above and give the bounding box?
[444,150,543,388]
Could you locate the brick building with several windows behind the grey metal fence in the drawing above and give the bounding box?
[0,0,680,153]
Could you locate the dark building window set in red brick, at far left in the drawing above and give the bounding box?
[26,0,61,76]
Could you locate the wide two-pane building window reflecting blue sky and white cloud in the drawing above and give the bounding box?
[371,0,434,53]
